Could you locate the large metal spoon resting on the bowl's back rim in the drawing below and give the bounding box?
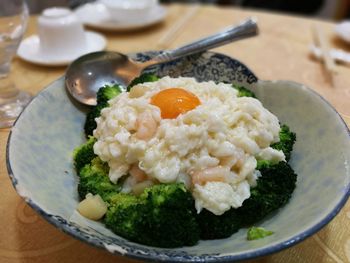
[65,19,258,105]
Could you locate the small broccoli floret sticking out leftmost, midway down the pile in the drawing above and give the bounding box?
[73,136,96,174]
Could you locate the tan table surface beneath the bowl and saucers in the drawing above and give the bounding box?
[0,5,350,263]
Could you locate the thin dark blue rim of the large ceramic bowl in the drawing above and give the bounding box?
[6,52,350,262]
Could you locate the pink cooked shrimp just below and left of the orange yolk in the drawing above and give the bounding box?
[136,111,158,141]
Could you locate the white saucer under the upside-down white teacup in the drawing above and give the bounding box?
[17,31,107,66]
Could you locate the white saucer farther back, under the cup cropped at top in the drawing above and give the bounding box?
[75,2,167,31]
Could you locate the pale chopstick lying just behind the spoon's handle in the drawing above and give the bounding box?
[157,4,200,49]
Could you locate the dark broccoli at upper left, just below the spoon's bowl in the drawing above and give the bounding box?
[84,85,121,137]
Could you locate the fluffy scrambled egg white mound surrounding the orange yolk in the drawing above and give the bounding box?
[94,77,285,215]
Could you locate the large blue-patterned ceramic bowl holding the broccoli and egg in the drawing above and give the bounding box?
[7,52,350,262]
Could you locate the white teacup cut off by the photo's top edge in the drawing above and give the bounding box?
[100,0,158,22]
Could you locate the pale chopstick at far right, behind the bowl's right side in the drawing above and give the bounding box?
[313,26,336,76]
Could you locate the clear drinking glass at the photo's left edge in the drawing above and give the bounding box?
[0,0,31,128]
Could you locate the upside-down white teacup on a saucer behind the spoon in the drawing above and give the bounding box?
[38,7,86,57]
